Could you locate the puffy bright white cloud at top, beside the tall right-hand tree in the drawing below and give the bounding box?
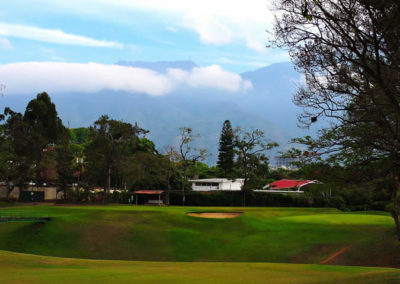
[101,0,273,51]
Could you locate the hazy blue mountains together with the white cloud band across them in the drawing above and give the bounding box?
[0,61,316,165]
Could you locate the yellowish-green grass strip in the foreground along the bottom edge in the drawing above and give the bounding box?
[0,251,400,284]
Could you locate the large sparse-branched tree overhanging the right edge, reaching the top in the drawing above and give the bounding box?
[273,0,400,239]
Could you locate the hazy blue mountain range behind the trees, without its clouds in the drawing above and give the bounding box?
[0,61,313,165]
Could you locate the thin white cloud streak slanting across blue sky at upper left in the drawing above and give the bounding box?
[0,23,122,48]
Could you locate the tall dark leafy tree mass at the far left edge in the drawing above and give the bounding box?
[2,93,66,190]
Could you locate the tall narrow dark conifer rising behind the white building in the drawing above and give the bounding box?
[217,120,234,177]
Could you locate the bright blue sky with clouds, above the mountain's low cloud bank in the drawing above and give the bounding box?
[0,0,289,72]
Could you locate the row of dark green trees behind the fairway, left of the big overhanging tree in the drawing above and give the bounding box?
[0,93,277,204]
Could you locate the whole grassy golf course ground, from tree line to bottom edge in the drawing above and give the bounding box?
[0,205,400,283]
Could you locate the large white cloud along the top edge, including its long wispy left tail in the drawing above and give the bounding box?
[32,0,273,52]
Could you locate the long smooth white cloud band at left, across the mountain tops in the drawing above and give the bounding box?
[0,62,172,95]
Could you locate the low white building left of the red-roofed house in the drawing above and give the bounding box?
[189,178,244,191]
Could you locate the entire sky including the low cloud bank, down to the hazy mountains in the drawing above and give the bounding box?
[0,0,289,100]
